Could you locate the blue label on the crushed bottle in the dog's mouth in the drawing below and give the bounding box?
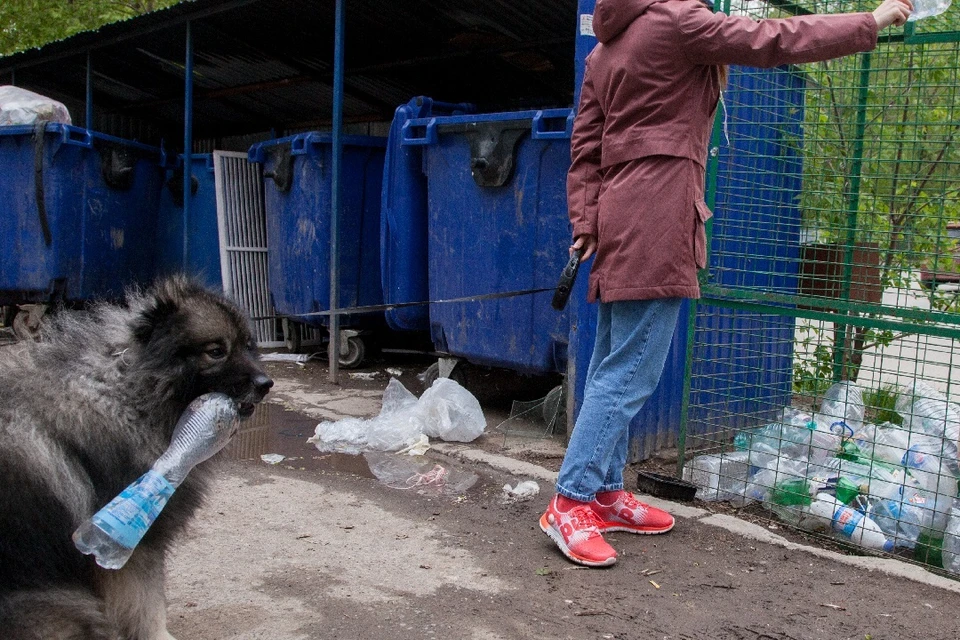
[92,470,174,549]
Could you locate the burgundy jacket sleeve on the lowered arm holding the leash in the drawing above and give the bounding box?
[567,58,604,238]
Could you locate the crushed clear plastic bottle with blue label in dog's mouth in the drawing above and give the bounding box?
[73,393,239,569]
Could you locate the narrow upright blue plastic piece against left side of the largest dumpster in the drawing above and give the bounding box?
[380,96,474,331]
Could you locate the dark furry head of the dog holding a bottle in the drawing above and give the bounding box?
[130,277,273,417]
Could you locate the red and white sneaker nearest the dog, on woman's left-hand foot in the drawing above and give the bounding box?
[540,496,617,567]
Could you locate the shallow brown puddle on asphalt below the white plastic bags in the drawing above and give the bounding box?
[223,402,483,496]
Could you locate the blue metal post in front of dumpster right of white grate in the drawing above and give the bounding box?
[329,0,345,384]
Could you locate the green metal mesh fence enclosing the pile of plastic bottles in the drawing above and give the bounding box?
[680,1,960,574]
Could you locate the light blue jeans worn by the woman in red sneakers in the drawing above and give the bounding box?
[557,298,681,502]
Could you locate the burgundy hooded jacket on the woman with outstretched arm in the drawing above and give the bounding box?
[567,0,877,302]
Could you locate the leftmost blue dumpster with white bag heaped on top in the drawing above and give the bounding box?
[0,124,163,304]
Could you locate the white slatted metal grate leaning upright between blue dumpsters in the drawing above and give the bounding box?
[213,151,284,347]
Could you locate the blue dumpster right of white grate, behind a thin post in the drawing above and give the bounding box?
[249,132,386,336]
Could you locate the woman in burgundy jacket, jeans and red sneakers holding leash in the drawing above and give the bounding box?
[540,0,913,566]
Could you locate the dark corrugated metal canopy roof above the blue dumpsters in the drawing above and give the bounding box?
[0,0,577,149]
